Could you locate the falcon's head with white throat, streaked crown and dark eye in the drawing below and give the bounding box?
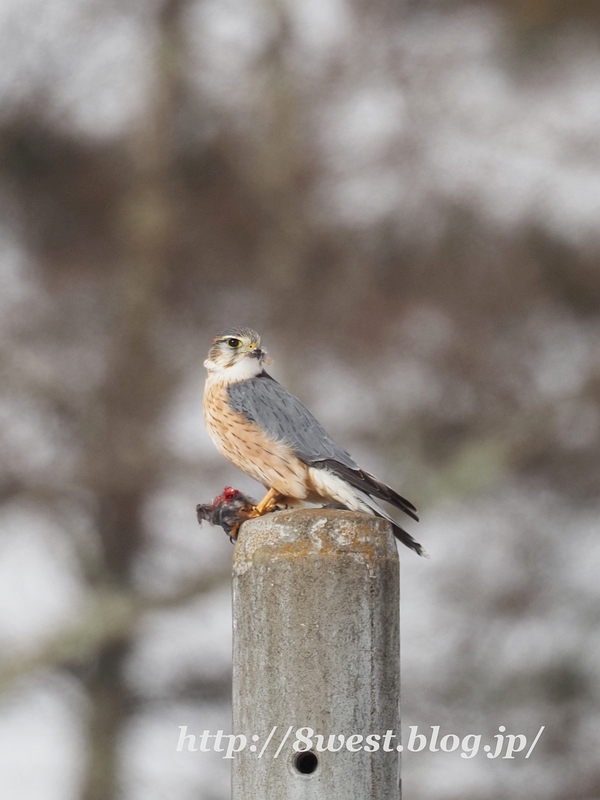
[204,328,270,382]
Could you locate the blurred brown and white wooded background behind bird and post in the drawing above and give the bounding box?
[0,0,600,800]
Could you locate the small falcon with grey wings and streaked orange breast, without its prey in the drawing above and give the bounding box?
[204,328,425,555]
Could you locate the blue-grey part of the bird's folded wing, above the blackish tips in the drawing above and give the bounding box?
[227,372,358,470]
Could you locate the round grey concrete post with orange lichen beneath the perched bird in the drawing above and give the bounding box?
[232,509,400,800]
